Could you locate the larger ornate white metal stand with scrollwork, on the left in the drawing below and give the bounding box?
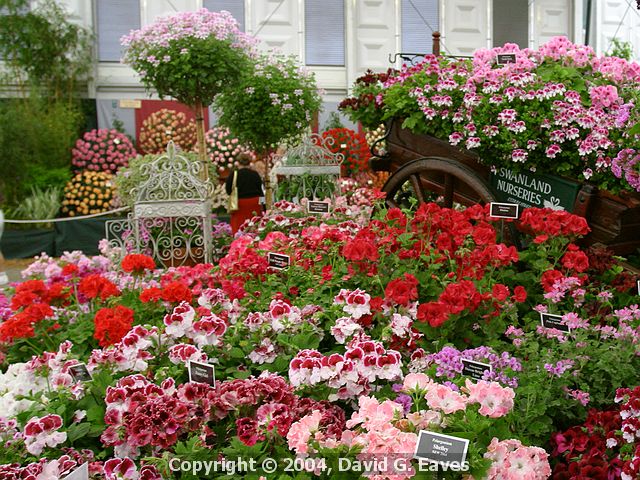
[106,142,212,267]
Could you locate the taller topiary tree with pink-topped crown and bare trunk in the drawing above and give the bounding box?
[122,8,256,182]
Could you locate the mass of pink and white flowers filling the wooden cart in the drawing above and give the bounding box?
[347,37,640,192]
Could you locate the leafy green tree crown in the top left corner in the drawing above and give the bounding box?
[0,0,92,100]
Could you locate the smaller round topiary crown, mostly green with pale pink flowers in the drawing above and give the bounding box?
[216,55,321,153]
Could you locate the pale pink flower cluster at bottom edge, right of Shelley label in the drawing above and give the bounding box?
[484,437,551,480]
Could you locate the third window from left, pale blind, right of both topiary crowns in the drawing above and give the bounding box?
[304,0,345,67]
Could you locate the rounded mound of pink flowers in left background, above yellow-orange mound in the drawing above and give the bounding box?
[71,128,137,173]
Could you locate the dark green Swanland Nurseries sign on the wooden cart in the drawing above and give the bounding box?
[491,168,580,212]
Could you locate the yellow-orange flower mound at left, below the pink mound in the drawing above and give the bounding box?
[61,170,114,217]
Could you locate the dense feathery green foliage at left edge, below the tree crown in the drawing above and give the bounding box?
[0,98,83,205]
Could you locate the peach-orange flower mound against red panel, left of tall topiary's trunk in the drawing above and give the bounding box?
[138,108,196,154]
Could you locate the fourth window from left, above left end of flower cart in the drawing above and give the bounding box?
[401,0,440,53]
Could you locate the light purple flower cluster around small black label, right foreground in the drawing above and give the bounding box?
[426,346,522,388]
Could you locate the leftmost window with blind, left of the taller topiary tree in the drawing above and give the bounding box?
[96,0,140,62]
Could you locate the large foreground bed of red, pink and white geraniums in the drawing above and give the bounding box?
[0,184,640,480]
